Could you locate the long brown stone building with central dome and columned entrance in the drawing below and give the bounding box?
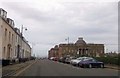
[48,37,104,57]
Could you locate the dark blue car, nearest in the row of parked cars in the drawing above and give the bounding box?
[79,58,104,68]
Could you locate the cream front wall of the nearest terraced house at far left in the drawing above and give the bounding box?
[2,17,15,59]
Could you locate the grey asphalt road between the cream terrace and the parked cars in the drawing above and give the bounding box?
[18,59,118,76]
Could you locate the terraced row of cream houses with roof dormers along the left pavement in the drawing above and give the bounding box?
[0,8,31,64]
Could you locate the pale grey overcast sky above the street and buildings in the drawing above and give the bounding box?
[0,0,118,56]
